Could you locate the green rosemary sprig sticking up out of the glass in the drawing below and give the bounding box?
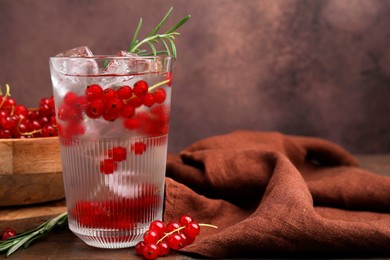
[128,7,191,59]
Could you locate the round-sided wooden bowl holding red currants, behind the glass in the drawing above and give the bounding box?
[0,137,65,206]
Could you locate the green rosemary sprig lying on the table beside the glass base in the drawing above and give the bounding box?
[0,212,68,257]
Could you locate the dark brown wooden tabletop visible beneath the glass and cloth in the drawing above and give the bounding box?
[3,154,390,260]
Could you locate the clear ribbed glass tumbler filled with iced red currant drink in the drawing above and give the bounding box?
[50,56,172,248]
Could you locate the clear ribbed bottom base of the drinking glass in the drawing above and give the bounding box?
[69,224,148,249]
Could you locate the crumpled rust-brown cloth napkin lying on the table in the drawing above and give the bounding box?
[164,131,390,258]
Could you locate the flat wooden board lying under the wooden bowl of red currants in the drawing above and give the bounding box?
[0,200,66,233]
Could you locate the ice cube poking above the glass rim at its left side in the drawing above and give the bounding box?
[52,46,99,76]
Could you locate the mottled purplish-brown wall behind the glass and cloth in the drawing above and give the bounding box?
[0,0,390,153]
